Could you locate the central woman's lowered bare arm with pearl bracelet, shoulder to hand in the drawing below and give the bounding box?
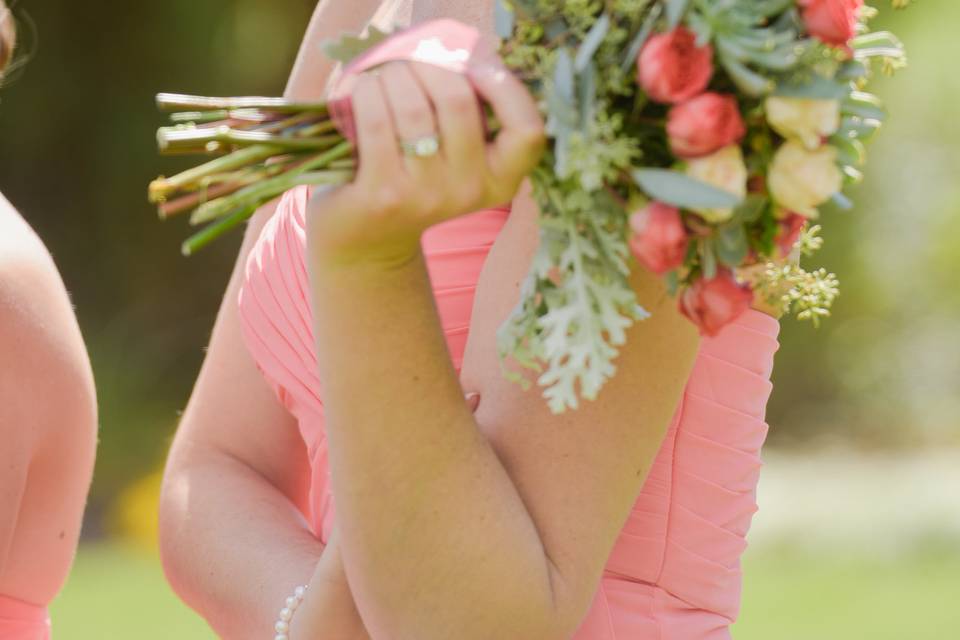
[160,0,379,640]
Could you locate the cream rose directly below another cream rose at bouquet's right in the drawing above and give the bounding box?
[767,140,843,218]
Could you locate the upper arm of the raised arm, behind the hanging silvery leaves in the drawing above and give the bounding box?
[461,185,699,632]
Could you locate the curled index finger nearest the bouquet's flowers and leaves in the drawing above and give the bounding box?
[469,67,546,190]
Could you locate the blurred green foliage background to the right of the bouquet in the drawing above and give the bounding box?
[768,0,960,448]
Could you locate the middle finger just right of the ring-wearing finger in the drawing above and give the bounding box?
[410,62,486,175]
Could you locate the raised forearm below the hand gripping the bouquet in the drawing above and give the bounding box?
[308,250,555,640]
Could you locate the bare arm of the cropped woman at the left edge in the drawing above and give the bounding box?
[0,201,97,593]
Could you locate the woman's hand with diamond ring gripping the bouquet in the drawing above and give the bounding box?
[307,61,546,267]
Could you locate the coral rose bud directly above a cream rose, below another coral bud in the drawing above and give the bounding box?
[667,93,747,158]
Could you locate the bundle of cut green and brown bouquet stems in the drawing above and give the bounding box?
[148,93,496,256]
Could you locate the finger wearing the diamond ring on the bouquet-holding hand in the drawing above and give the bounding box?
[380,62,444,178]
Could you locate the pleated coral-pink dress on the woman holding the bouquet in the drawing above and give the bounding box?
[238,182,780,640]
